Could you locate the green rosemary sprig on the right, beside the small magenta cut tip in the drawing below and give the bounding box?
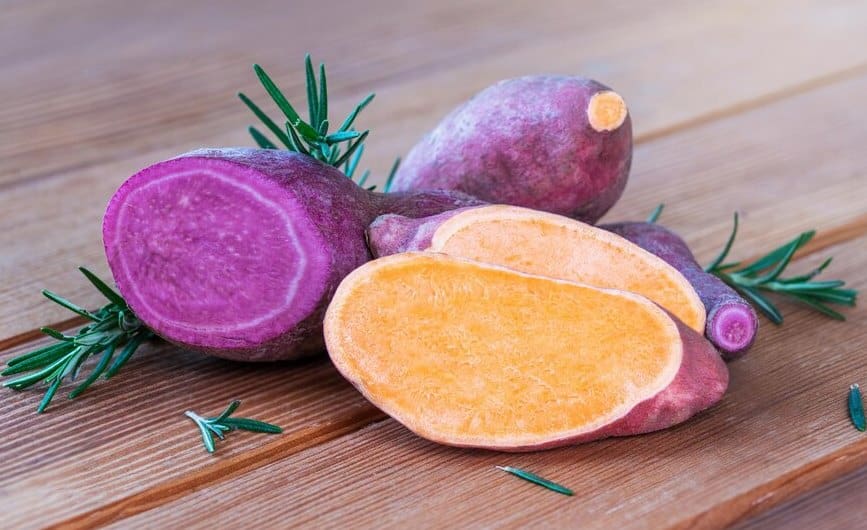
[705,213,858,324]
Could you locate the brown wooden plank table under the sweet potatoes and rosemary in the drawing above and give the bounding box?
[0,0,867,528]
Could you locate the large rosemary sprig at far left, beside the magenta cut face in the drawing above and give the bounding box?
[0,267,154,413]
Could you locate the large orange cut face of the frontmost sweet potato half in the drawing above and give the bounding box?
[325,253,682,448]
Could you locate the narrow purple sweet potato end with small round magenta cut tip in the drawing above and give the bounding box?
[600,222,759,361]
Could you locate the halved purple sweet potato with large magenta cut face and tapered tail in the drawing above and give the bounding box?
[103,148,480,361]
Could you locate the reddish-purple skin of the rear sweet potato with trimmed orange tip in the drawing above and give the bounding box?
[392,76,632,223]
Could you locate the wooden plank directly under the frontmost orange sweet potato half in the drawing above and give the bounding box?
[105,238,867,528]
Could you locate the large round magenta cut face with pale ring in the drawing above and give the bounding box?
[103,153,328,350]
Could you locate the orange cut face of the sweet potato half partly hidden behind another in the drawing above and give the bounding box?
[430,206,706,333]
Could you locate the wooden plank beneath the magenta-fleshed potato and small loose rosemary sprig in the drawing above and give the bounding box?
[0,72,867,524]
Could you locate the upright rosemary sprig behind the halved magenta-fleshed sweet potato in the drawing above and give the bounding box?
[238,54,400,191]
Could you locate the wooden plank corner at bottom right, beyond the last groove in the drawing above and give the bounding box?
[734,468,867,530]
